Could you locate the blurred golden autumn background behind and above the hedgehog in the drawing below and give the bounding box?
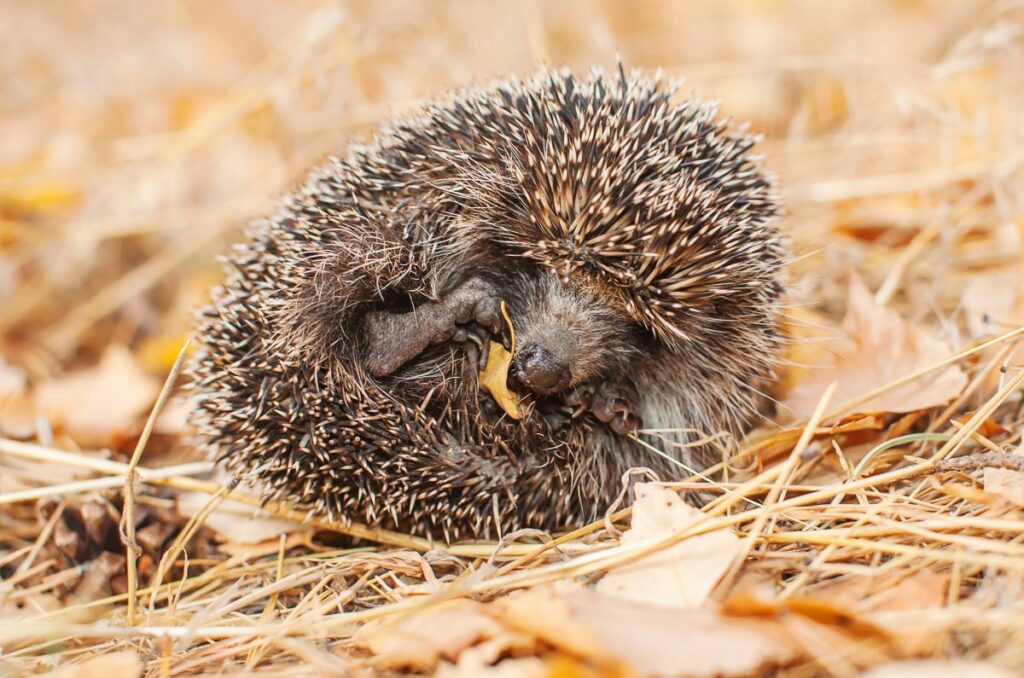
[0,0,1024,444]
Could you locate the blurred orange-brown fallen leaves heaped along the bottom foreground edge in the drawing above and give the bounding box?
[356,587,800,678]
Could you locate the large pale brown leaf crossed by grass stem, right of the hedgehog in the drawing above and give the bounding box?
[779,280,967,420]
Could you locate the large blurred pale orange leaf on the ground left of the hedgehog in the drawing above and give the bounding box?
[36,345,160,443]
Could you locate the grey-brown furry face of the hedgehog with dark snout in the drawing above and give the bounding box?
[509,272,639,395]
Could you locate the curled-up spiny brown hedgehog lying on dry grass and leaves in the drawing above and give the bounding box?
[189,67,787,542]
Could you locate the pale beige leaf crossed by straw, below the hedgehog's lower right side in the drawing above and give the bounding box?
[597,483,740,608]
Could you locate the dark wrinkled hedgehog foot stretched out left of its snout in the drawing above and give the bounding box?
[364,278,502,377]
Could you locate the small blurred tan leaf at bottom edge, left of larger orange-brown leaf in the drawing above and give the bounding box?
[355,600,531,672]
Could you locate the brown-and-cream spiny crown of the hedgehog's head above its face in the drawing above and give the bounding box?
[435,73,784,350]
